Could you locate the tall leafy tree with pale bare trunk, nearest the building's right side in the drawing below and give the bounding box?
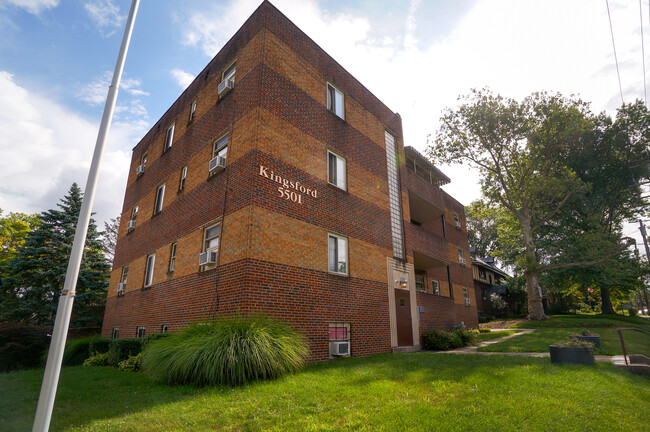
[428,89,626,320]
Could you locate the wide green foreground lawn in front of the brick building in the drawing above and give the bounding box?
[0,353,650,432]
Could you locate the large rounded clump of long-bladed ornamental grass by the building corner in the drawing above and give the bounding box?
[142,317,309,386]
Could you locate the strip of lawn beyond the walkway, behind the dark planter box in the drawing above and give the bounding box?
[478,327,650,356]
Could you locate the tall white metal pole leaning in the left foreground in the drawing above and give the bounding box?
[32,0,140,432]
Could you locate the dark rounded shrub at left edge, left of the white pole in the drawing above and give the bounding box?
[0,322,50,372]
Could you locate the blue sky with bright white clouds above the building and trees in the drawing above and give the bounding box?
[0,0,650,243]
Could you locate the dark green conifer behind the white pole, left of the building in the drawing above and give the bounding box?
[0,183,109,326]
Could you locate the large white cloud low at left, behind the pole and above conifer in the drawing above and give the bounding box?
[0,71,149,226]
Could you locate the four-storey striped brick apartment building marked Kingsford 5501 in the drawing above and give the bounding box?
[103,1,478,360]
